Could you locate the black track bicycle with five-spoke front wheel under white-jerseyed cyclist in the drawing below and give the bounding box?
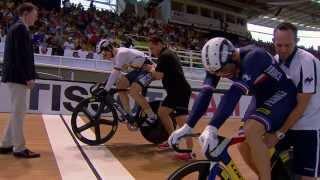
[71,83,176,145]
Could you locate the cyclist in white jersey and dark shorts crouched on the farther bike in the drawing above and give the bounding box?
[97,39,157,123]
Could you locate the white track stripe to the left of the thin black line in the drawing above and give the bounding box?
[42,115,97,180]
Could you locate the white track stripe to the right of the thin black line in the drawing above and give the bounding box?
[63,116,134,180]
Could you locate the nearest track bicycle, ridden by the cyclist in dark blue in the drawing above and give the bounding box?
[168,130,294,180]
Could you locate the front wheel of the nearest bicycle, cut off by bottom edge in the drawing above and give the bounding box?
[168,160,231,180]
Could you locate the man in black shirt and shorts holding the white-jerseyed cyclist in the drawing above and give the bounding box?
[149,36,193,159]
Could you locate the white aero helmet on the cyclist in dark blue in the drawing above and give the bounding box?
[201,37,235,73]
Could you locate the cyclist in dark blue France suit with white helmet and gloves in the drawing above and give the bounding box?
[170,38,296,180]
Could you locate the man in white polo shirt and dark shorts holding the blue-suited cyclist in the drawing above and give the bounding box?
[267,22,320,180]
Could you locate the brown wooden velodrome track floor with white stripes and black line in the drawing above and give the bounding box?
[0,113,257,180]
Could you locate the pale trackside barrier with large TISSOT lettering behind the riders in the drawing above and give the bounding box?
[0,77,251,117]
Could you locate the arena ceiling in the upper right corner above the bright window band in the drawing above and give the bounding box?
[207,0,320,31]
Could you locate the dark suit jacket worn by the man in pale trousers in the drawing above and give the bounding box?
[2,20,36,85]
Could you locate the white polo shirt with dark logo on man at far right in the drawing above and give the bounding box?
[275,48,320,130]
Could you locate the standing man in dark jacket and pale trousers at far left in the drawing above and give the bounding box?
[0,3,40,158]
